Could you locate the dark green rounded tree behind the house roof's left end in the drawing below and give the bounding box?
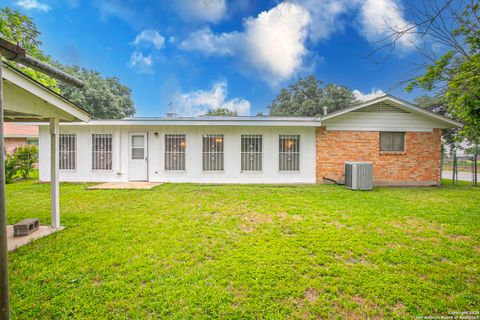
[57,64,135,119]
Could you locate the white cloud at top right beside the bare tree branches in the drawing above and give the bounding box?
[359,0,416,49]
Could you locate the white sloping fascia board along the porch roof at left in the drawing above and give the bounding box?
[3,64,90,122]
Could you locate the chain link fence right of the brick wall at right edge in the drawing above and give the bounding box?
[442,152,480,186]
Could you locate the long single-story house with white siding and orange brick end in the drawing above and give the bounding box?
[40,95,461,186]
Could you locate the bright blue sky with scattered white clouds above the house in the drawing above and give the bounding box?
[11,0,426,116]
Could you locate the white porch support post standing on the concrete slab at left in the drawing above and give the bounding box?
[50,119,60,229]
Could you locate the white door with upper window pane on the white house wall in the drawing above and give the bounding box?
[128,132,148,181]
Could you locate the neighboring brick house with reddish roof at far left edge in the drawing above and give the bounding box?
[3,122,38,154]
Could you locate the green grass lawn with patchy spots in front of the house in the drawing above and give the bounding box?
[7,182,480,319]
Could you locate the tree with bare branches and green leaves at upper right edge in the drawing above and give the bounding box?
[372,0,480,144]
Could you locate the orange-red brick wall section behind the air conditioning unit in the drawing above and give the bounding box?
[316,127,441,186]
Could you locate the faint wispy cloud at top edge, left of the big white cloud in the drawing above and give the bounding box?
[176,0,227,22]
